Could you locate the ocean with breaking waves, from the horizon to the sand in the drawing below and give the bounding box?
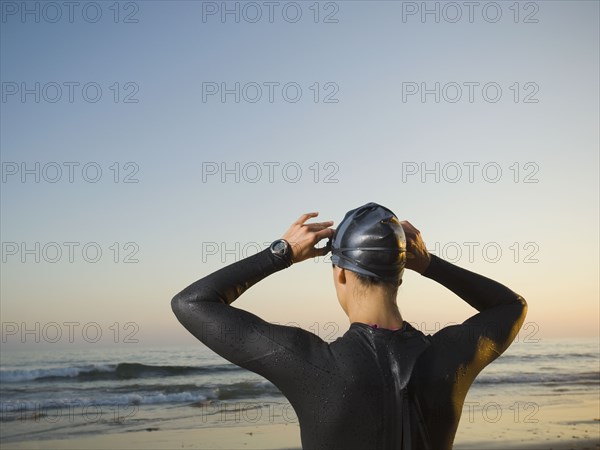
[0,338,600,444]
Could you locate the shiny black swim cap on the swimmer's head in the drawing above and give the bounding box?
[331,202,406,282]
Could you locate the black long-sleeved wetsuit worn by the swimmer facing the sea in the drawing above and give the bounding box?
[172,249,526,450]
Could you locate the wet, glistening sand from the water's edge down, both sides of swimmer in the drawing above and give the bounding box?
[0,395,600,450]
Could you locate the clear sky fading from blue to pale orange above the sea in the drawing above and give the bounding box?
[0,0,600,348]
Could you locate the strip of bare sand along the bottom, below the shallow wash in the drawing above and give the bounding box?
[2,398,600,450]
